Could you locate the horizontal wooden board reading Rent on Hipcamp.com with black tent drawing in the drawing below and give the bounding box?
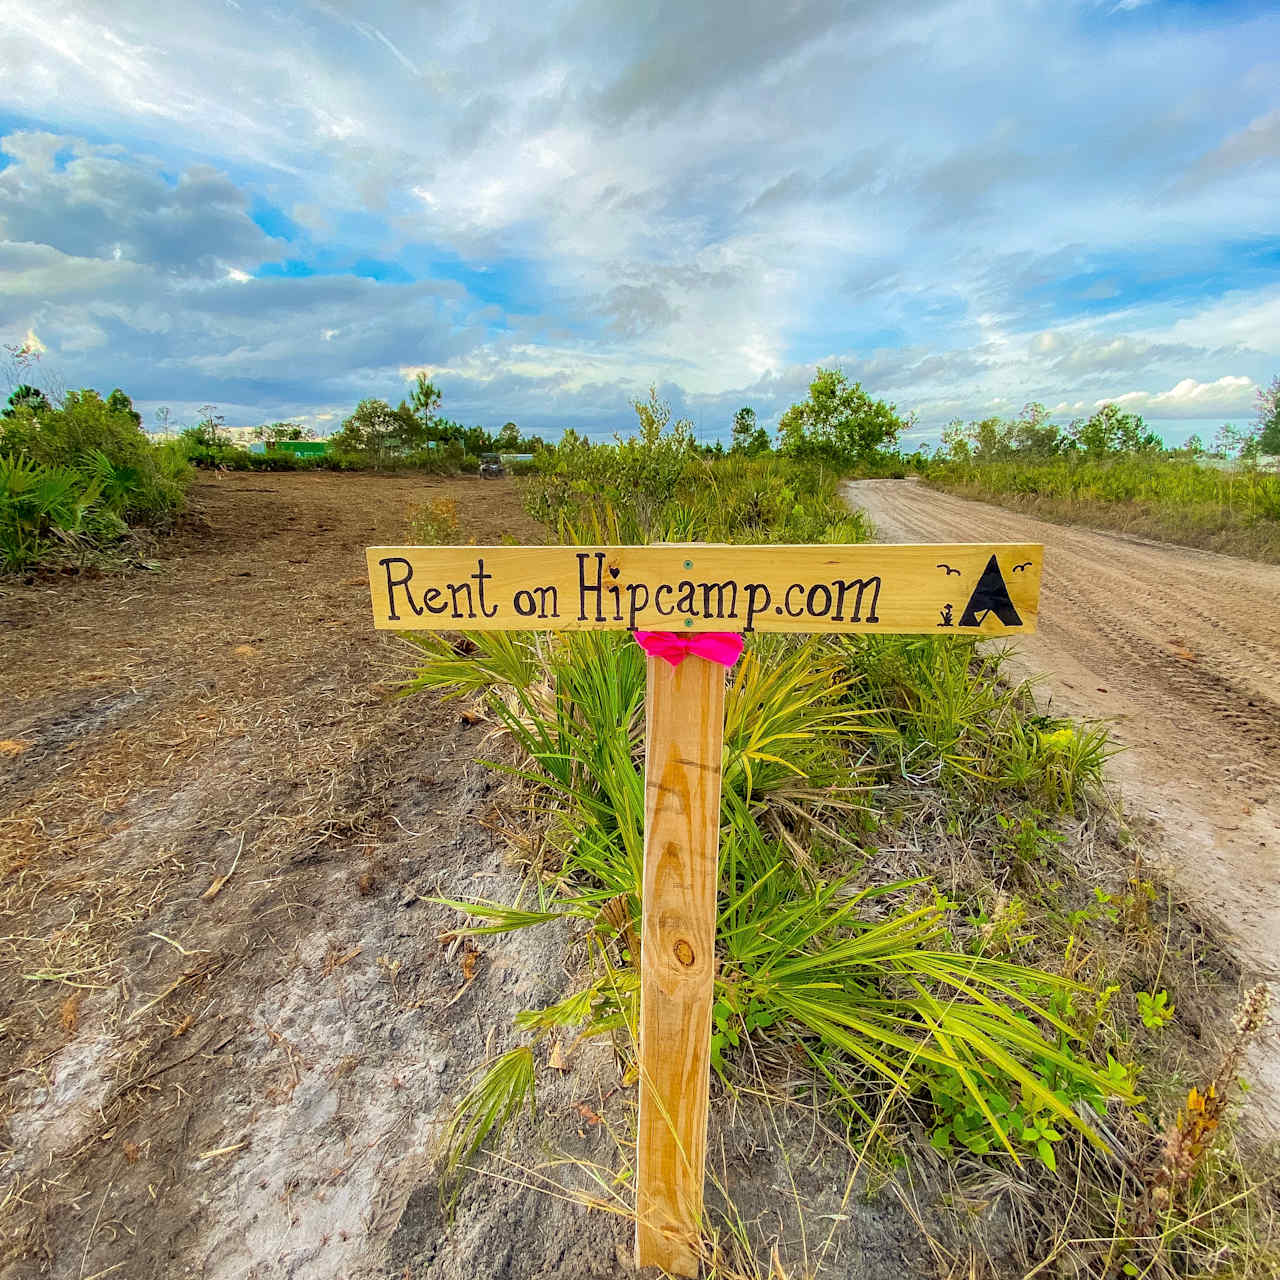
[367,543,1043,635]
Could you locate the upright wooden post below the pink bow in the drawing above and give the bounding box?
[636,657,724,1276]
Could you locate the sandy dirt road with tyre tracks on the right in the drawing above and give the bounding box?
[846,480,1280,1132]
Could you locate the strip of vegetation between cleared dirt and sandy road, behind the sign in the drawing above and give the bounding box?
[396,385,1277,1276]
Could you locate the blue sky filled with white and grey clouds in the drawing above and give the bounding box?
[0,0,1280,445]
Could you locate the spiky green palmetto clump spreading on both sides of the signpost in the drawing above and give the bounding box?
[412,619,1132,1177]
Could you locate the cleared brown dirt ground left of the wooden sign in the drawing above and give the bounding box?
[0,474,576,1277]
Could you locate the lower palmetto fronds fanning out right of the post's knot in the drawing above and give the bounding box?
[717,808,1133,1158]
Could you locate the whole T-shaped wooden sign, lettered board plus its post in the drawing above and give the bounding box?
[367,543,1043,1276]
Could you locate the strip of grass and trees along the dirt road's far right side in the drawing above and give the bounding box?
[924,391,1280,563]
